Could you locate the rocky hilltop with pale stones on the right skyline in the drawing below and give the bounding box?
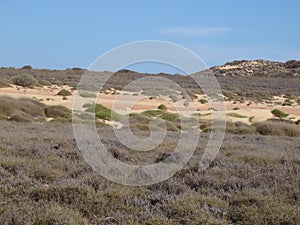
[211,60,300,77]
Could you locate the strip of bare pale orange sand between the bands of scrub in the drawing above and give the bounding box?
[0,86,300,124]
